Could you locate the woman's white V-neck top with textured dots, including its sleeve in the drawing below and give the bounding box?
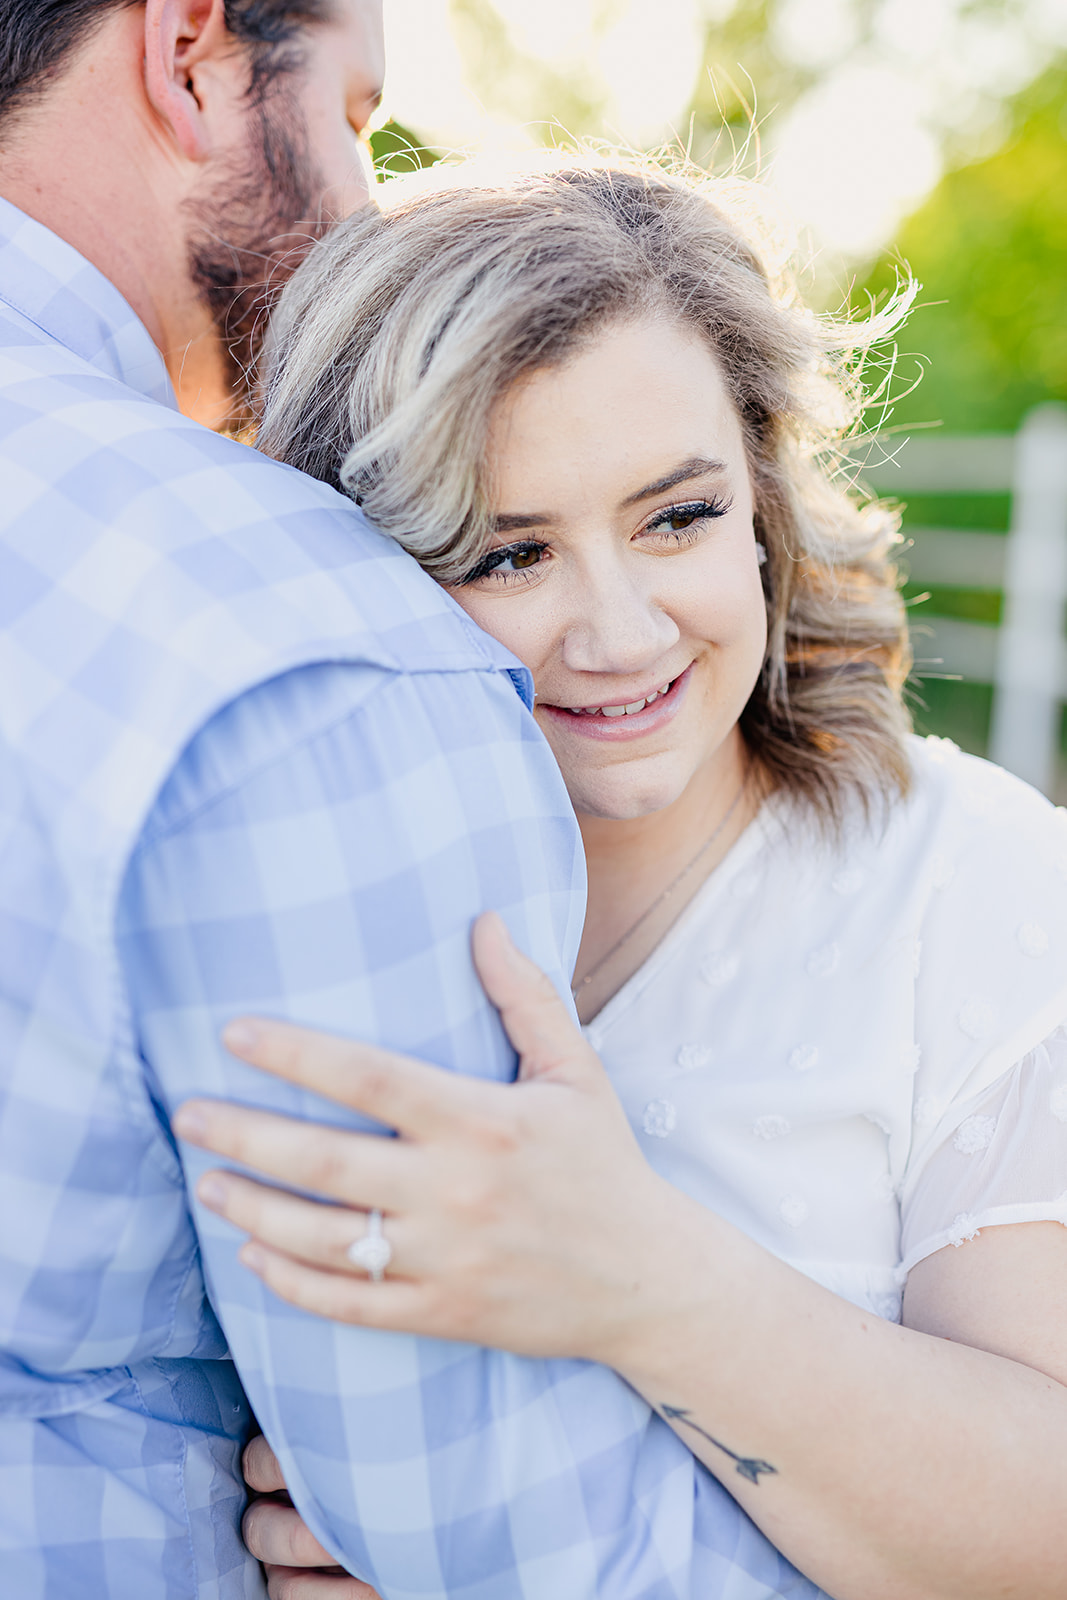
[585,739,1067,1318]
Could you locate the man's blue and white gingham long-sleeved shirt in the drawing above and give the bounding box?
[0,202,817,1600]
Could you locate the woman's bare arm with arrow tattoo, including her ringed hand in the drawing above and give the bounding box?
[182,928,1067,1600]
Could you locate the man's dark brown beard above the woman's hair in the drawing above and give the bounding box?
[189,86,330,429]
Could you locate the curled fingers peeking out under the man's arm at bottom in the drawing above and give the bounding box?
[242,1434,379,1600]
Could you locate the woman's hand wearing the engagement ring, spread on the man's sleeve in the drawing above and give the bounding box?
[174,914,688,1362]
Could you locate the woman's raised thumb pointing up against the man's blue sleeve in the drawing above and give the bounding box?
[472,910,603,1083]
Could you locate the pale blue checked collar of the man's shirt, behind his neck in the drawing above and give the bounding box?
[0,198,176,406]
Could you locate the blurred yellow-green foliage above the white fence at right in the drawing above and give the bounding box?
[853,62,1067,432]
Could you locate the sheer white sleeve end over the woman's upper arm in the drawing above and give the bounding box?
[901,1026,1067,1275]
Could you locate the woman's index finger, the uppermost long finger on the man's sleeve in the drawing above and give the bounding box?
[222,1018,495,1138]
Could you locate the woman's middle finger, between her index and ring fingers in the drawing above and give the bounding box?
[173,1101,416,1210]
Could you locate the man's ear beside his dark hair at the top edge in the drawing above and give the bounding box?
[144,0,234,162]
